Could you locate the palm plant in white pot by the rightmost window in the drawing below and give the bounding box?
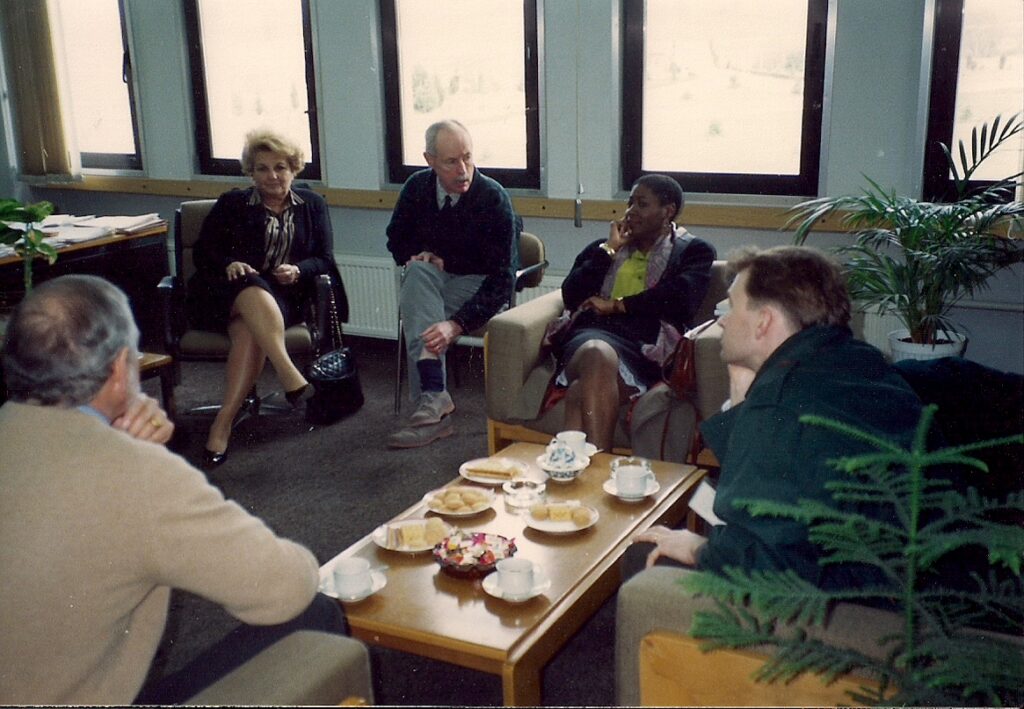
[786,114,1024,360]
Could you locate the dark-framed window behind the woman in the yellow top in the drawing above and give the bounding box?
[622,0,827,196]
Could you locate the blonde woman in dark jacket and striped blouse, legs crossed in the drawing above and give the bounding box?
[186,131,348,466]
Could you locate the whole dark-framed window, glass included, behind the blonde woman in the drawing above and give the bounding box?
[185,0,321,179]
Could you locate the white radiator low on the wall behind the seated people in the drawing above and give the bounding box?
[335,254,562,340]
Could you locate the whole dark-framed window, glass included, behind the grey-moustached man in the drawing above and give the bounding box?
[381,0,541,187]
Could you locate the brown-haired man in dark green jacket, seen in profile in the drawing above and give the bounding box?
[636,247,922,588]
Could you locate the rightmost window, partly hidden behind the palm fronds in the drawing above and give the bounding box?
[925,0,1024,199]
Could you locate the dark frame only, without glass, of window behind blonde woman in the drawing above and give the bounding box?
[182,0,323,180]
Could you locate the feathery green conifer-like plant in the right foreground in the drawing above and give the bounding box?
[682,406,1024,706]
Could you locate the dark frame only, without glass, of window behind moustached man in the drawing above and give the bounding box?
[380,0,541,190]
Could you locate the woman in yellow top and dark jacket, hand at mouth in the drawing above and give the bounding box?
[550,175,715,450]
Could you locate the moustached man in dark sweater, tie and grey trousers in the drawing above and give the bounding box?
[387,121,520,448]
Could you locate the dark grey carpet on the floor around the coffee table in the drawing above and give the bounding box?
[136,338,614,706]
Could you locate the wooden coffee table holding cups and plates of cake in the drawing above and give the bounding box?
[321,443,705,705]
